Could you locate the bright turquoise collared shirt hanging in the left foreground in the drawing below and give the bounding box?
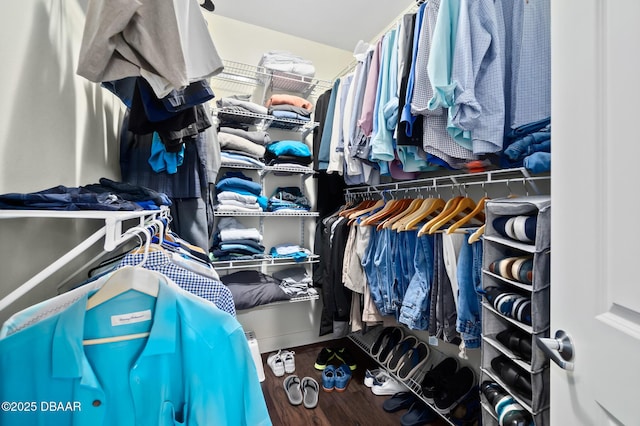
[0,278,271,426]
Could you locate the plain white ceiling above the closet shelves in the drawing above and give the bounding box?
[213,0,416,51]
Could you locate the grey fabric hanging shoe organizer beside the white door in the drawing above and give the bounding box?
[481,196,551,426]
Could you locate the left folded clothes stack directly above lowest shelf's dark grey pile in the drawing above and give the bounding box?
[211,217,265,261]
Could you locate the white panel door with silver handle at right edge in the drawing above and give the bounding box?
[551,0,640,426]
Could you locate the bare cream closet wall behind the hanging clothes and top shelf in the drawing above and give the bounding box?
[0,0,351,322]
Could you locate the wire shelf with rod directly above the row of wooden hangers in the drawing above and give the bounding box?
[345,168,551,197]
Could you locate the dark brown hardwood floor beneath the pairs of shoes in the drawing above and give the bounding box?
[262,338,447,426]
